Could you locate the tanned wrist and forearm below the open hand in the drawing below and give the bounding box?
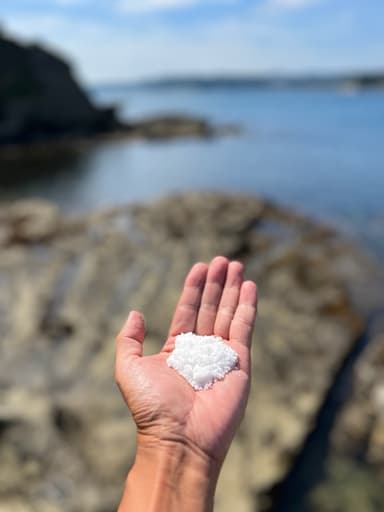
[118,438,220,512]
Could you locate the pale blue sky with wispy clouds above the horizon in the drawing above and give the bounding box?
[0,0,384,83]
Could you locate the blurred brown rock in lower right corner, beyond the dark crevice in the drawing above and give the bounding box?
[310,311,384,512]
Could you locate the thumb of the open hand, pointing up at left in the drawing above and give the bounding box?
[116,311,145,369]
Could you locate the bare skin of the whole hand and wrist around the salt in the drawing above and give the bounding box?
[115,256,257,512]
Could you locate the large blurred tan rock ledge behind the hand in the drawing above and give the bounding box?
[0,194,376,512]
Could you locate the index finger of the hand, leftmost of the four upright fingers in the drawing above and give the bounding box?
[169,263,208,336]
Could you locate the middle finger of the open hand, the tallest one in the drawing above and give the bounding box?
[196,256,228,335]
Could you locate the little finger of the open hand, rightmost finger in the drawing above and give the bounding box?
[229,281,257,347]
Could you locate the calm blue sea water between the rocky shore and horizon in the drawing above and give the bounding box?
[0,86,384,255]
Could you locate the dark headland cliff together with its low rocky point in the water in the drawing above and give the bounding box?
[0,33,216,146]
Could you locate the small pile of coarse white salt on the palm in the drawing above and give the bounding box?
[167,332,238,390]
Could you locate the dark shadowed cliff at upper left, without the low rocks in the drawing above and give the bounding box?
[0,34,118,143]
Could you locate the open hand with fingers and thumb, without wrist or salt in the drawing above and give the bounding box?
[116,256,256,463]
